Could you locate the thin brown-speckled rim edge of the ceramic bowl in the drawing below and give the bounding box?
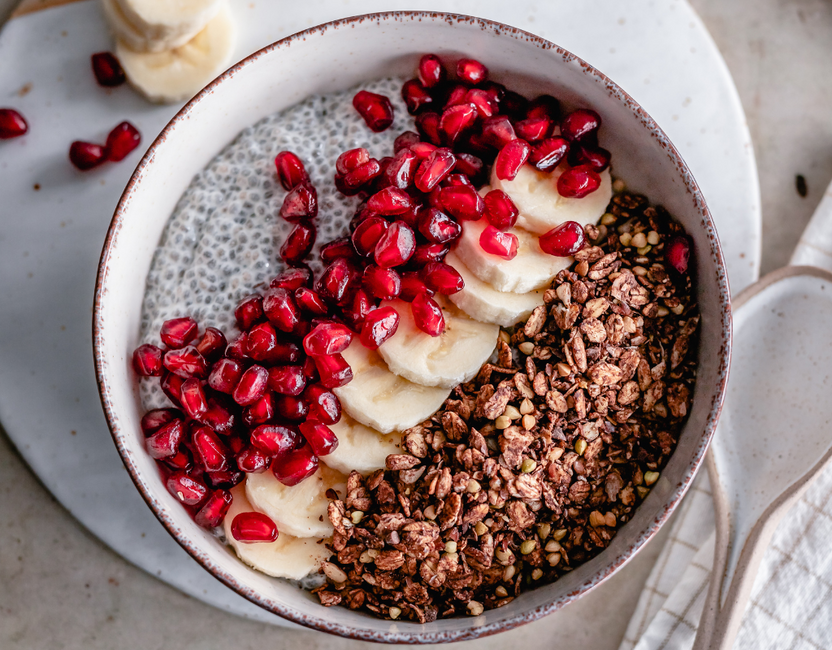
[92,10,732,644]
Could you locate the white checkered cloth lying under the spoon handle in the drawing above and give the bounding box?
[619,460,832,650]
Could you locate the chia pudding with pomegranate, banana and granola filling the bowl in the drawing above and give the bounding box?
[133,55,699,623]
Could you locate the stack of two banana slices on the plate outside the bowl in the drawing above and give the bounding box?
[101,0,236,103]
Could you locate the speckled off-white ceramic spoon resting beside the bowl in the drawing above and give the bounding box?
[694,177,832,650]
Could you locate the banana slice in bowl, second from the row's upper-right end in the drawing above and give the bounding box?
[452,219,572,292]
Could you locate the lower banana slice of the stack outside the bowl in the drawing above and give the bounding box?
[116,4,236,103]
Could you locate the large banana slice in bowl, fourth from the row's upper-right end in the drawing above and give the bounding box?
[378,296,500,388]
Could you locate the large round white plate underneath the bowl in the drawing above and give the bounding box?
[0,0,761,624]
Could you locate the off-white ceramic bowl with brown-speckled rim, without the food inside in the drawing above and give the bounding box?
[93,12,731,643]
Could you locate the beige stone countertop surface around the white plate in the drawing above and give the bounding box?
[0,0,832,650]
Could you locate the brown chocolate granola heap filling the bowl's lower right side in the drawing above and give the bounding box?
[316,193,699,623]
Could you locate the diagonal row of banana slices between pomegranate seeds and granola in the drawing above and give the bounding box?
[225,166,612,579]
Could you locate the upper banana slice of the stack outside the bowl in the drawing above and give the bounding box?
[114,0,223,52]
